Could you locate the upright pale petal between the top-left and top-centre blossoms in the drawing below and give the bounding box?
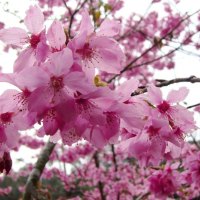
[47,20,66,50]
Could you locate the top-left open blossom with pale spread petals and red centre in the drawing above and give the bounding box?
[0,6,48,72]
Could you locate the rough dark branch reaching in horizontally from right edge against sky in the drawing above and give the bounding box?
[131,76,200,96]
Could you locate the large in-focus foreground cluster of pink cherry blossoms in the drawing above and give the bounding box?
[0,3,196,175]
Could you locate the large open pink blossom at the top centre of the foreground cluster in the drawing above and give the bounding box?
[68,11,124,76]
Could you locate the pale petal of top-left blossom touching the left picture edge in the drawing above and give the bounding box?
[0,28,28,46]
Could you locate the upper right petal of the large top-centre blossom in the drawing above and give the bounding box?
[97,19,121,37]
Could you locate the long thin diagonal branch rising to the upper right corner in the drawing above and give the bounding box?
[107,9,200,83]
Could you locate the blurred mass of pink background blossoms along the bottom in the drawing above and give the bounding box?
[0,141,200,200]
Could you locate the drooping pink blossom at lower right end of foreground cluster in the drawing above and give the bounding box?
[119,119,170,166]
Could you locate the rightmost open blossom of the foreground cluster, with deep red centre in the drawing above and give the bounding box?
[146,85,196,145]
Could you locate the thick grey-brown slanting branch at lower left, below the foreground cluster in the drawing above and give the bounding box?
[23,142,56,200]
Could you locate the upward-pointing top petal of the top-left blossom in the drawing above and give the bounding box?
[24,6,44,35]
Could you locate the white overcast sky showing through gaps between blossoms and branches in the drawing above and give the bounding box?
[0,0,200,170]
